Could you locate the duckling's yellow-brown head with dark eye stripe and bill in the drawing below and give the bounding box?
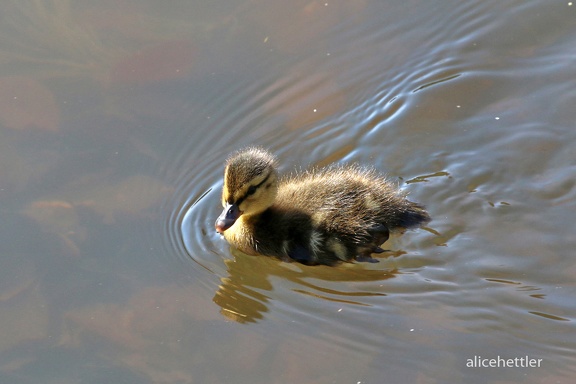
[215,148,278,233]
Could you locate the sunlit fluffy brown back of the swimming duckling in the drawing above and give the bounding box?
[274,166,430,231]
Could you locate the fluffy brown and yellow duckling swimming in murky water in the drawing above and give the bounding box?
[215,147,431,266]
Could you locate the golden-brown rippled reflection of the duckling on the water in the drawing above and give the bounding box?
[213,249,405,323]
